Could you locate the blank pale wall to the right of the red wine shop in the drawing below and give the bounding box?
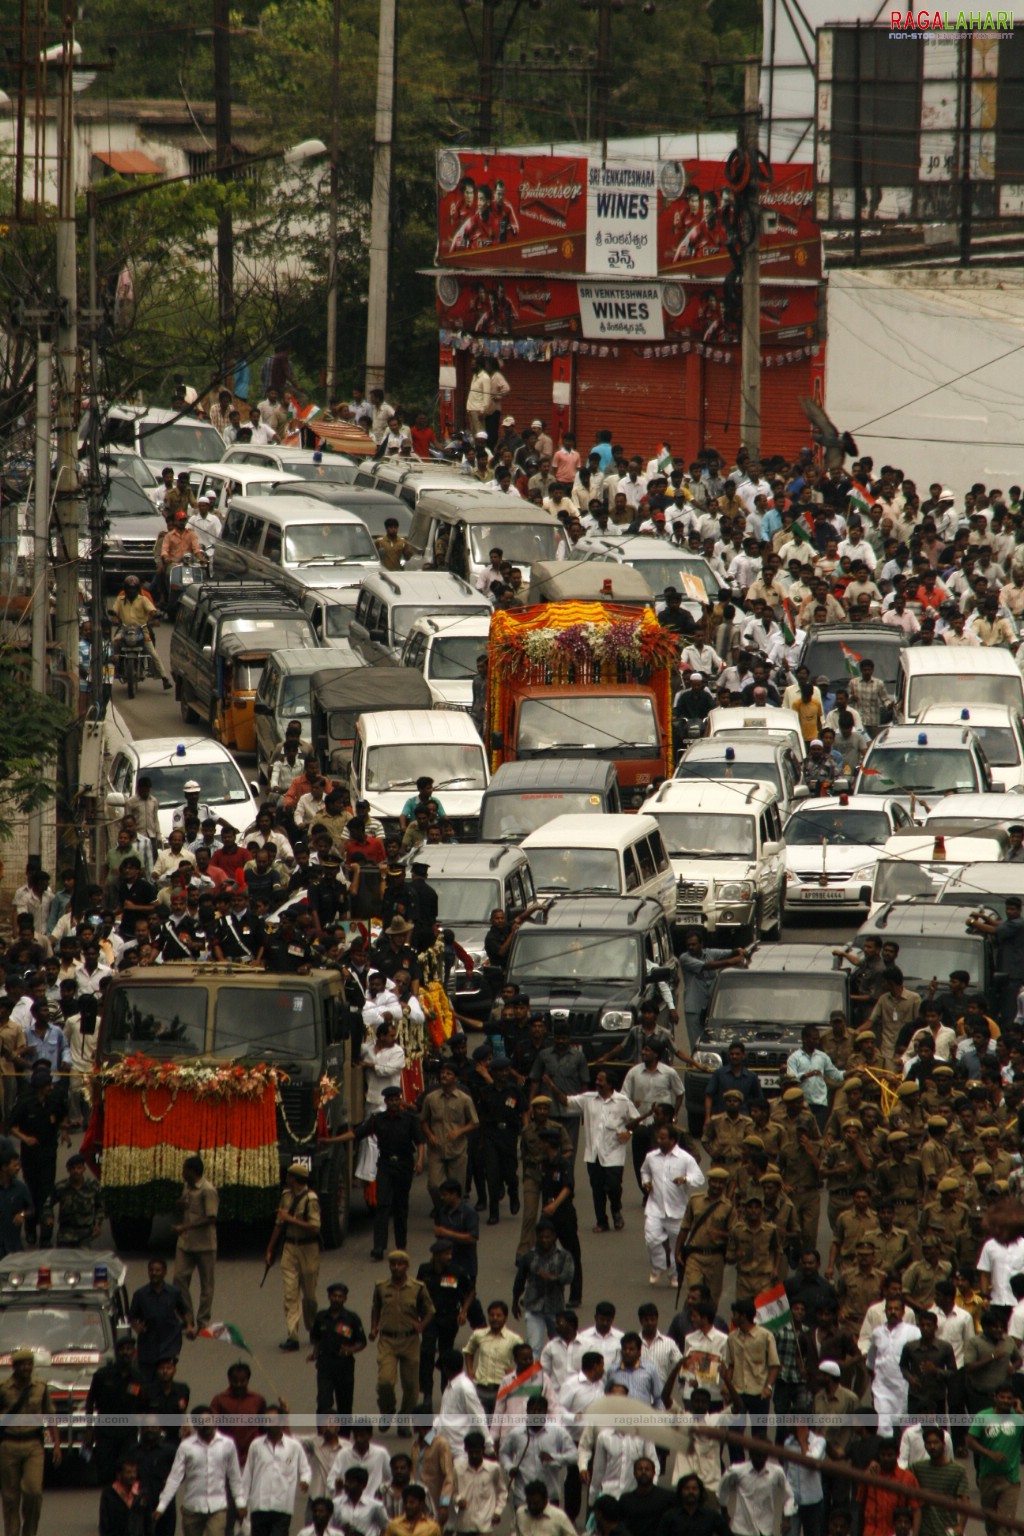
[826,269,1024,496]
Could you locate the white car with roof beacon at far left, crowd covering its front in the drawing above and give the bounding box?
[106,734,259,839]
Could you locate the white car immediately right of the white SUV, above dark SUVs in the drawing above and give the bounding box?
[783,794,913,912]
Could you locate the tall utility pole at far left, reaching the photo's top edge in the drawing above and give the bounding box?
[52,0,80,703]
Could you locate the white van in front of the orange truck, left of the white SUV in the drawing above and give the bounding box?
[519,813,676,917]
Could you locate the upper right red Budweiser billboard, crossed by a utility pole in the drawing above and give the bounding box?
[657,160,821,278]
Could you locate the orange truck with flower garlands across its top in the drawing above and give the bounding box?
[485,602,677,809]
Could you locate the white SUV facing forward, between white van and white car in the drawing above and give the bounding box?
[643,779,786,945]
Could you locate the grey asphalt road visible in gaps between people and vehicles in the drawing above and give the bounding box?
[41,627,872,1536]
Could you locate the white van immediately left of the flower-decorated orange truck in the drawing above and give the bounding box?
[350,710,490,842]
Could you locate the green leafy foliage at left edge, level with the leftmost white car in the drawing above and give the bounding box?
[0,650,71,842]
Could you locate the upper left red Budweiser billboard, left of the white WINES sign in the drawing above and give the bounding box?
[438,149,586,272]
